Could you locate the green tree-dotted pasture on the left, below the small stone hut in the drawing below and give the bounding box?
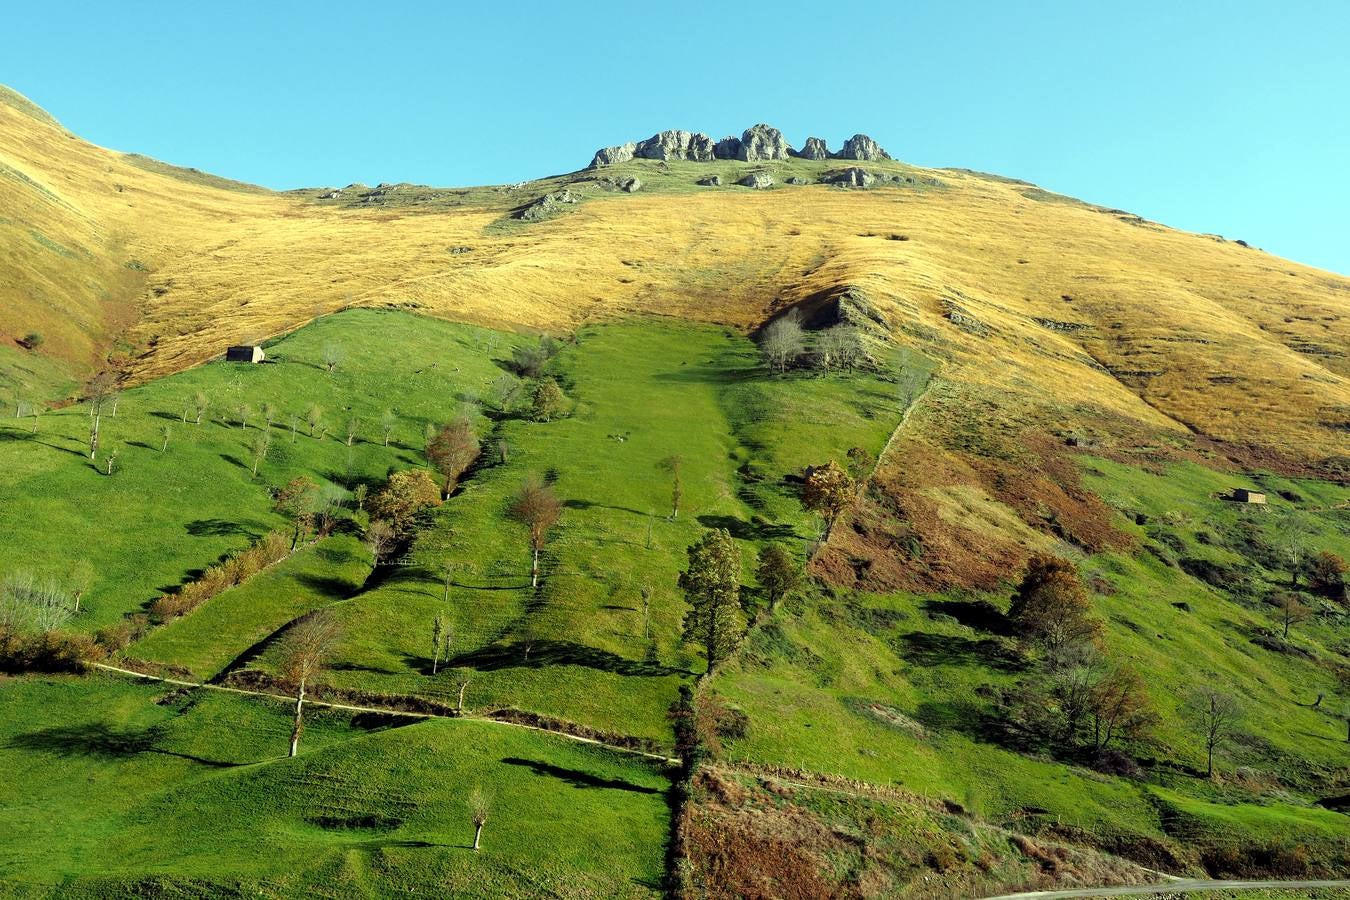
[0,310,514,630]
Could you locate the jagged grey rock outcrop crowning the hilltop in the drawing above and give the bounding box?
[587,123,891,169]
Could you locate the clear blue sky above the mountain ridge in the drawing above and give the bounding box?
[0,0,1350,273]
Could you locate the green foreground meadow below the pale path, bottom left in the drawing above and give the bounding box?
[0,677,670,897]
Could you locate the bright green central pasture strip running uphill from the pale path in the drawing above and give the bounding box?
[237,321,899,741]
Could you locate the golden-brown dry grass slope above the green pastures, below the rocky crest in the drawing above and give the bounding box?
[0,92,1350,466]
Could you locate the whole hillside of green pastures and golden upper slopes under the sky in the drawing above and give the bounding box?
[0,87,1350,897]
